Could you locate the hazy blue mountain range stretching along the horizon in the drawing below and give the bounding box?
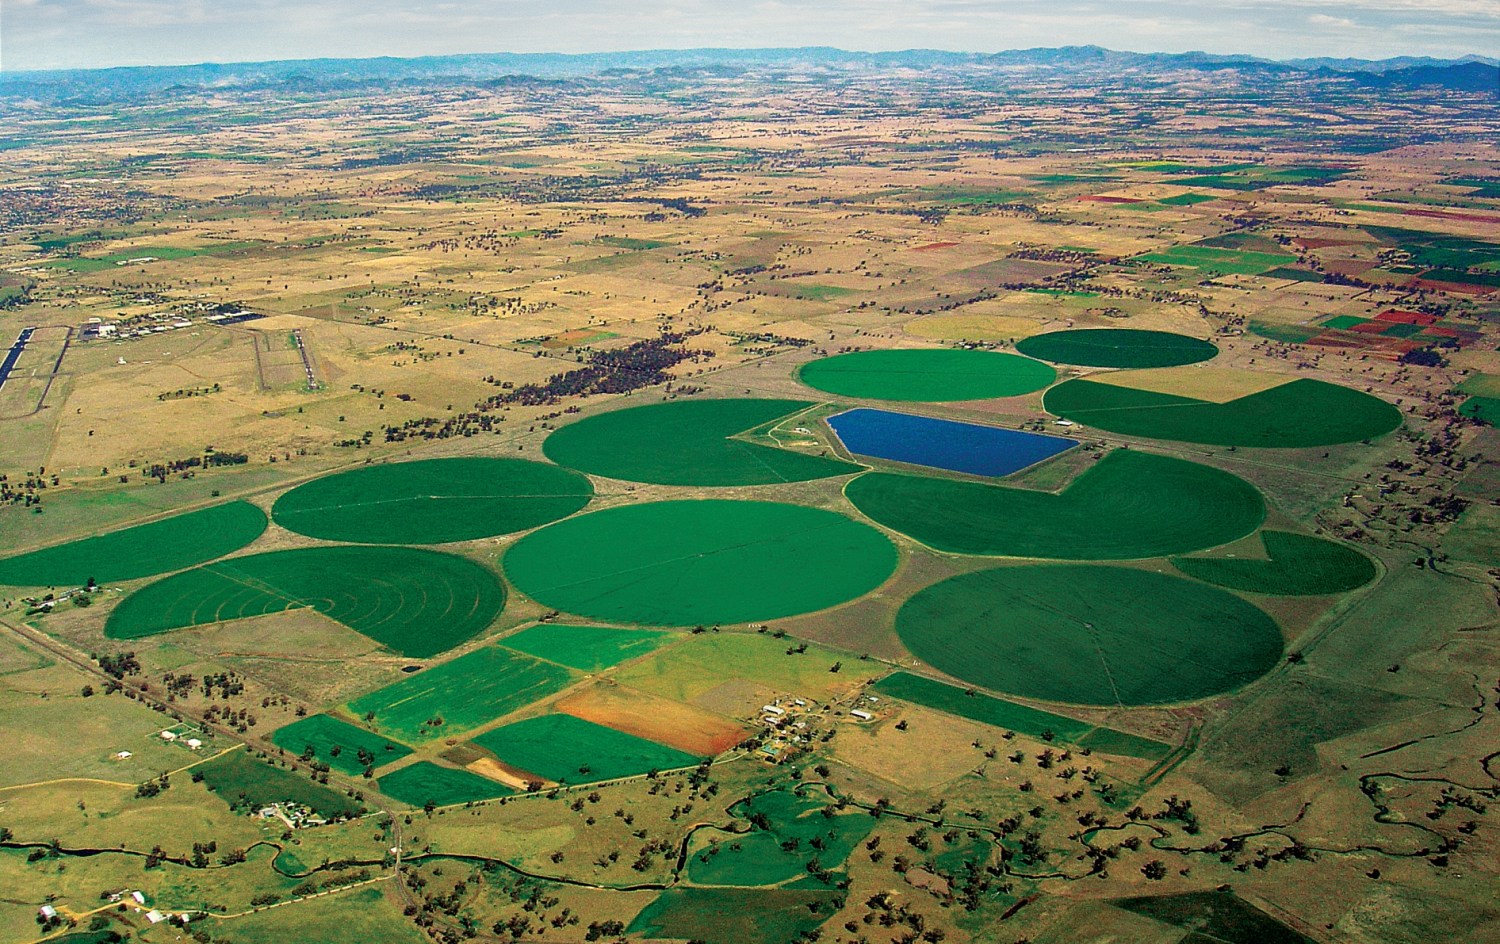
[0,45,1500,104]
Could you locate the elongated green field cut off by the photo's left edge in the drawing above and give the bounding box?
[0,501,266,587]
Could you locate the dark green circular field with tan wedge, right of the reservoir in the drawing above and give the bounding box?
[1043,378,1401,449]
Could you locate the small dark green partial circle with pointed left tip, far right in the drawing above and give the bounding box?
[1172,531,1376,596]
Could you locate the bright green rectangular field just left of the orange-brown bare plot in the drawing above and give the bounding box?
[350,645,573,743]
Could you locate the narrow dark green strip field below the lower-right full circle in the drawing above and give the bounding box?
[870,672,1172,761]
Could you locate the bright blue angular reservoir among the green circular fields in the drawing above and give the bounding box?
[828,407,1079,476]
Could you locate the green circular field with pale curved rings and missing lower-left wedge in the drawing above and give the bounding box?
[104,546,506,659]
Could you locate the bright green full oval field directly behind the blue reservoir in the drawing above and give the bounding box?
[797,348,1058,402]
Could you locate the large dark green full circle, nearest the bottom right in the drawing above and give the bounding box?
[896,564,1283,705]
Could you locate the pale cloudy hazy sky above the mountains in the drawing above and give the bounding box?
[0,0,1500,71]
